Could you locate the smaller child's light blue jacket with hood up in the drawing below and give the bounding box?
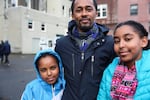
[21,49,65,100]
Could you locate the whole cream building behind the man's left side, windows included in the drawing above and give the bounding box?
[0,0,71,54]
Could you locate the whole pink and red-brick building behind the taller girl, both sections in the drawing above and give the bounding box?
[97,0,150,39]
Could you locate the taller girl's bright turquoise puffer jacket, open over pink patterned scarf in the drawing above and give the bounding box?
[97,50,150,100]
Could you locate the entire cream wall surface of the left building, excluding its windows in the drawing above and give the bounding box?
[0,0,70,54]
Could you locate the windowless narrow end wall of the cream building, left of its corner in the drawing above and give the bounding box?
[4,7,22,52]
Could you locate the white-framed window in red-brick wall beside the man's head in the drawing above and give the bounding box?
[97,4,107,18]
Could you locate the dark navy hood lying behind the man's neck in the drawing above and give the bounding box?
[68,20,109,34]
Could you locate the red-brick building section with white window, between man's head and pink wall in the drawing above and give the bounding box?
[96,0,118,34]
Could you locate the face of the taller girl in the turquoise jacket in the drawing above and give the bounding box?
[114,25,147,67]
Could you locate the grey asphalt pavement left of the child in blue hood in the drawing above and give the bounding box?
[0,54,36,100]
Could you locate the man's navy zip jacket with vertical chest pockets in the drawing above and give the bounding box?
[55,21,114,100]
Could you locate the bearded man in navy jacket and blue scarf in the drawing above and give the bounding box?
[55,0,114,100]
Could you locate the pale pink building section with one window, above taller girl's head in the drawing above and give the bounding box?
[117,0,150,39]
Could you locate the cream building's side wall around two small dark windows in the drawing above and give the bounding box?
[22,6,68,53]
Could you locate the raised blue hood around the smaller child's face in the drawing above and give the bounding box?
[34,49,65,90]
